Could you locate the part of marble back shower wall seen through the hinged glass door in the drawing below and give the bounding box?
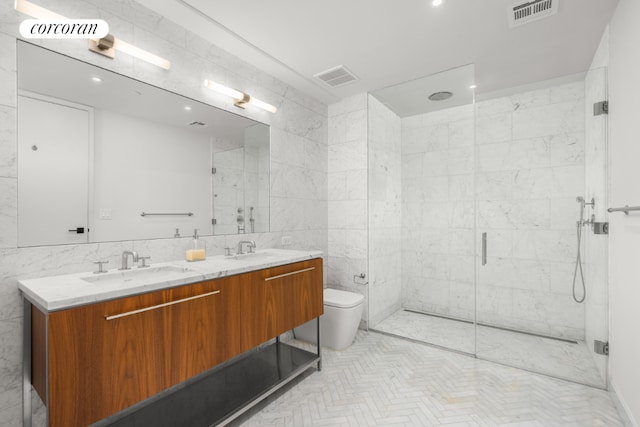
[476,81,585,339]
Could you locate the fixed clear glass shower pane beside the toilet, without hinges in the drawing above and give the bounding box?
[368,65,476,354]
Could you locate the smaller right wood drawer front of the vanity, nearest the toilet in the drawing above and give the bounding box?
[241,258,323,351]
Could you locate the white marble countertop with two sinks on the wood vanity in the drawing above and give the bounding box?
[18,249,322,312]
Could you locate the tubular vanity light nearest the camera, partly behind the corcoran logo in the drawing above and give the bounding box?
[14,0,171,70]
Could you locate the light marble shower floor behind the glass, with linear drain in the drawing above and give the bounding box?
[373,310,606,387]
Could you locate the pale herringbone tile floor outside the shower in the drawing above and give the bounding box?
[238,331,622,427]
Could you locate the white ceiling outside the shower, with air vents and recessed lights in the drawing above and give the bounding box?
[137,0,617,110]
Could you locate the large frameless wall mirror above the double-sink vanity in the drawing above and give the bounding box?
[18,41,270,247]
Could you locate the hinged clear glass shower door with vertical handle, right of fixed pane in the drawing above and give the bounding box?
[475,69,608,388]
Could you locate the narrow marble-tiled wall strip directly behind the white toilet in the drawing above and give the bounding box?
[327,94,368,327]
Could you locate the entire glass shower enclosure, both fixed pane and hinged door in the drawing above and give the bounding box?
[368,66,608,388]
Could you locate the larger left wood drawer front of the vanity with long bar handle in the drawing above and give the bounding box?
[48,276,240,427]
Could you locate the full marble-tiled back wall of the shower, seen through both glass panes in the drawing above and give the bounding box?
[402,81,585,339]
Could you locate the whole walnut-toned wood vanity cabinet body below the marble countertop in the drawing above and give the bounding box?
[31,258,323,427]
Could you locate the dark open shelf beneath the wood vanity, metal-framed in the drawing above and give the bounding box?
[94,341,320,427]
